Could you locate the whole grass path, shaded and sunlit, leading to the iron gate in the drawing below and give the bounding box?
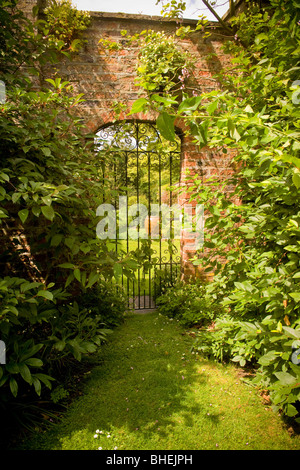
[17,312,300,450]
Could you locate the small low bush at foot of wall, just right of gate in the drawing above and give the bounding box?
[156,282,214,326]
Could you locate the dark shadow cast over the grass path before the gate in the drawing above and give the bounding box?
[18,313,219,449]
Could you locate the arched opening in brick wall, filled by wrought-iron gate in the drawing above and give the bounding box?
[95,121,182,309]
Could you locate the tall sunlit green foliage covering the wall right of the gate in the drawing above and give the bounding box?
[133,0,300,416]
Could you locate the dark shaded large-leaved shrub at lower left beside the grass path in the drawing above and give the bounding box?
[0,277,113,401]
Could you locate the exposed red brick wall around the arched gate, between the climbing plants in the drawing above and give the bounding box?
[22,0,231,274]
